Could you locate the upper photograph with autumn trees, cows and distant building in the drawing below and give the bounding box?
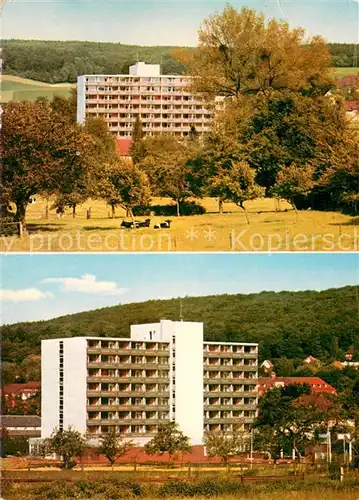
[0,0,359,254]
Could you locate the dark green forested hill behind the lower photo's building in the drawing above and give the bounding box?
[1,286,359,363]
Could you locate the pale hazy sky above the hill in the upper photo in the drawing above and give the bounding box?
[3,0,359,45]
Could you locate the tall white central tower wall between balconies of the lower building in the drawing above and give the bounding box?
[174,321,204,444]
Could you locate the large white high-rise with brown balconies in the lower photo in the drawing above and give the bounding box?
[41,320,258,444]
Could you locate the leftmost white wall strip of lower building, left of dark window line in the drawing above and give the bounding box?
[41,339,59,438]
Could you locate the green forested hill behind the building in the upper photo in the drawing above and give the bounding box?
[2,40,359,83]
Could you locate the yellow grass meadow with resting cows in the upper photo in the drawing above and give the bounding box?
[1,198,359,252]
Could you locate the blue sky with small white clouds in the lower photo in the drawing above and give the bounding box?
[0,253,359,323]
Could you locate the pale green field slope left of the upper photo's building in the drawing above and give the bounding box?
[0,75,76,103]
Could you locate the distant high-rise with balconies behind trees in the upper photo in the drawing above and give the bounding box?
[77,62,211,150]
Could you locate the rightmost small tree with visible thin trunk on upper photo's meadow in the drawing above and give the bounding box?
[272,163,315,216]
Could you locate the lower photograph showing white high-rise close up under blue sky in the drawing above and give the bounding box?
[0,253,359,500]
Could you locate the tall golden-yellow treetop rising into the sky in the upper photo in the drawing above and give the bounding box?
[182,5,333,100]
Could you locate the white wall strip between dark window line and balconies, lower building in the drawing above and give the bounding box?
[64,337,87,433]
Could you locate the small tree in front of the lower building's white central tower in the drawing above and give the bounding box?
[145,421,192,462]
